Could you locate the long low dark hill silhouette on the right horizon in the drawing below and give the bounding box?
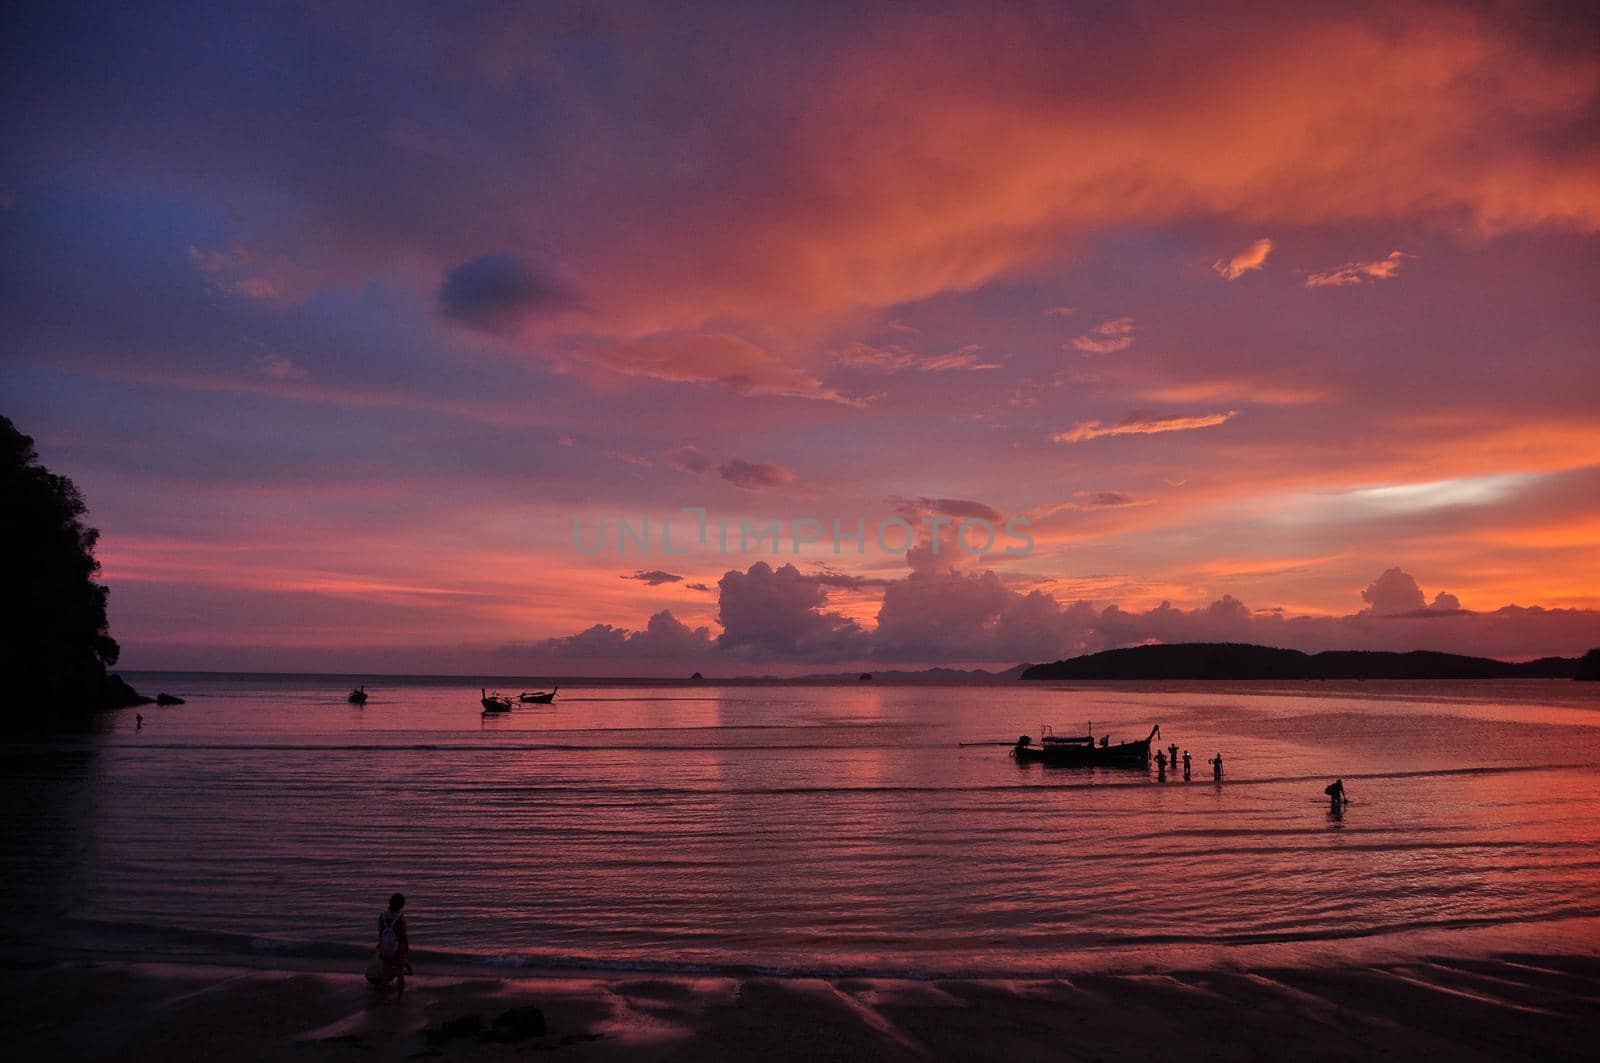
[1022,642,1597,679]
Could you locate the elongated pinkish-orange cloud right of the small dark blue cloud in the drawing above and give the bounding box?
[578,333,862,405]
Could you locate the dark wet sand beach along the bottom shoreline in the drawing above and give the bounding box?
[0,954,1600,1063]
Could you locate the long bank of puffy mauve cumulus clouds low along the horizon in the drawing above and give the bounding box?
[525,562,1600,663]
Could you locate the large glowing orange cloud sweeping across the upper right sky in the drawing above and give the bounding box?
[581,6,1600,336]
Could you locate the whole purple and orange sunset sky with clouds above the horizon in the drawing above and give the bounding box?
[0,3,1600,676]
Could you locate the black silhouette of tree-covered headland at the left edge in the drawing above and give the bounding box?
[0,416,142,714]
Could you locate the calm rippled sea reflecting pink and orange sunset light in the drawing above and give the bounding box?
[0,674,1600,975]
